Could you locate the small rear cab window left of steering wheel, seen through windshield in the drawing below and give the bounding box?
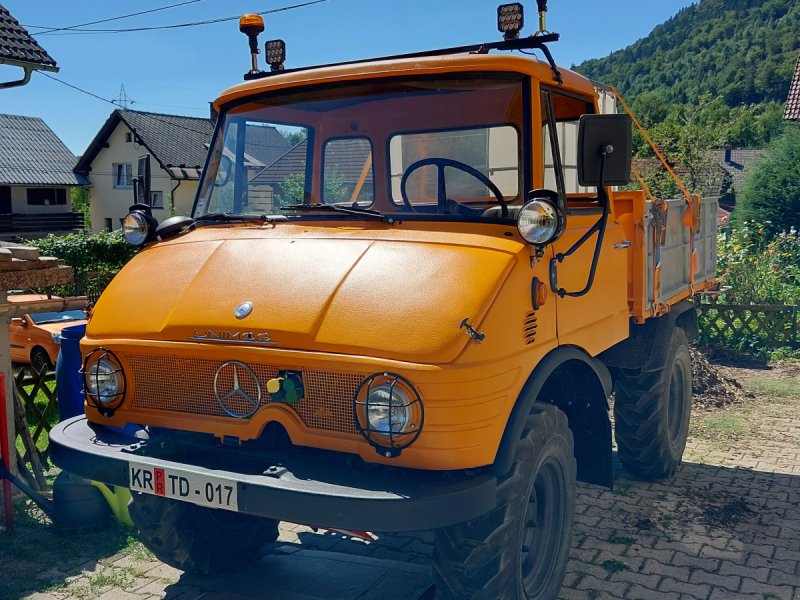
[322,138,375,205]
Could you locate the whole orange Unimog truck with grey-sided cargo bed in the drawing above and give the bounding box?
[51,2,716,599]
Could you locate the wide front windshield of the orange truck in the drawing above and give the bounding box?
[195,75,526,220]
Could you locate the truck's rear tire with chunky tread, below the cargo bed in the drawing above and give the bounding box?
[614,327,692,480]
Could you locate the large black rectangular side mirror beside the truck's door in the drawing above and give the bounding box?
[578,115,633,187]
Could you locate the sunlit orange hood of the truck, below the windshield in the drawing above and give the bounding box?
[87,225,516,363]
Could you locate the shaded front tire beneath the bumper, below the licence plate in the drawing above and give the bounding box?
[129,493,278,575]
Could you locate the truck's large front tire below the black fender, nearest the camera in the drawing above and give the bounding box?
[433,403,576,600]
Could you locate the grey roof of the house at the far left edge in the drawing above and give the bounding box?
[0,114,86,185]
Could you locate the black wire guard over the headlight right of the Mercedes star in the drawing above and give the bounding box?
[353,372,425,458]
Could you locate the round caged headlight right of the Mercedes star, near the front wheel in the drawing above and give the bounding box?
[353,373,424,458]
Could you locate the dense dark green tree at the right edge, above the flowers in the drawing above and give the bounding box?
[735,127,800,234]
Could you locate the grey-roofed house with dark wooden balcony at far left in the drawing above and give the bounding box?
[0,114,88,240]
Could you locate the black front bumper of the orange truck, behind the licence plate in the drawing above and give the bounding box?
[50,417,497,532]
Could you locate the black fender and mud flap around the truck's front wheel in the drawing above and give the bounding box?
[491,346,614,487]
